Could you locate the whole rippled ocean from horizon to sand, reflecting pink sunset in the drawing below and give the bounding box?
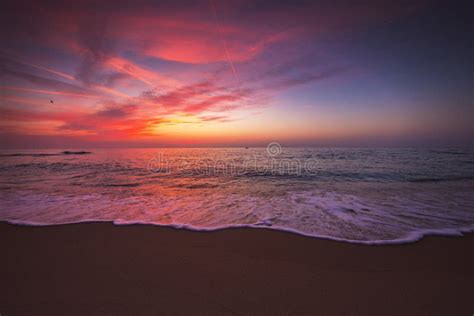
[0,147,474,244]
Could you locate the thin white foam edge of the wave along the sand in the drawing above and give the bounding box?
[0,219,474,245]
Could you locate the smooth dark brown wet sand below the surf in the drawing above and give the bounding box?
[0,223,474,316]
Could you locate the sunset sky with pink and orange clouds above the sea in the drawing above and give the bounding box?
[0,0,474,148]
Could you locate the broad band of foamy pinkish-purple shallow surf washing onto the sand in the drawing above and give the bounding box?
[0,186,474,244]
